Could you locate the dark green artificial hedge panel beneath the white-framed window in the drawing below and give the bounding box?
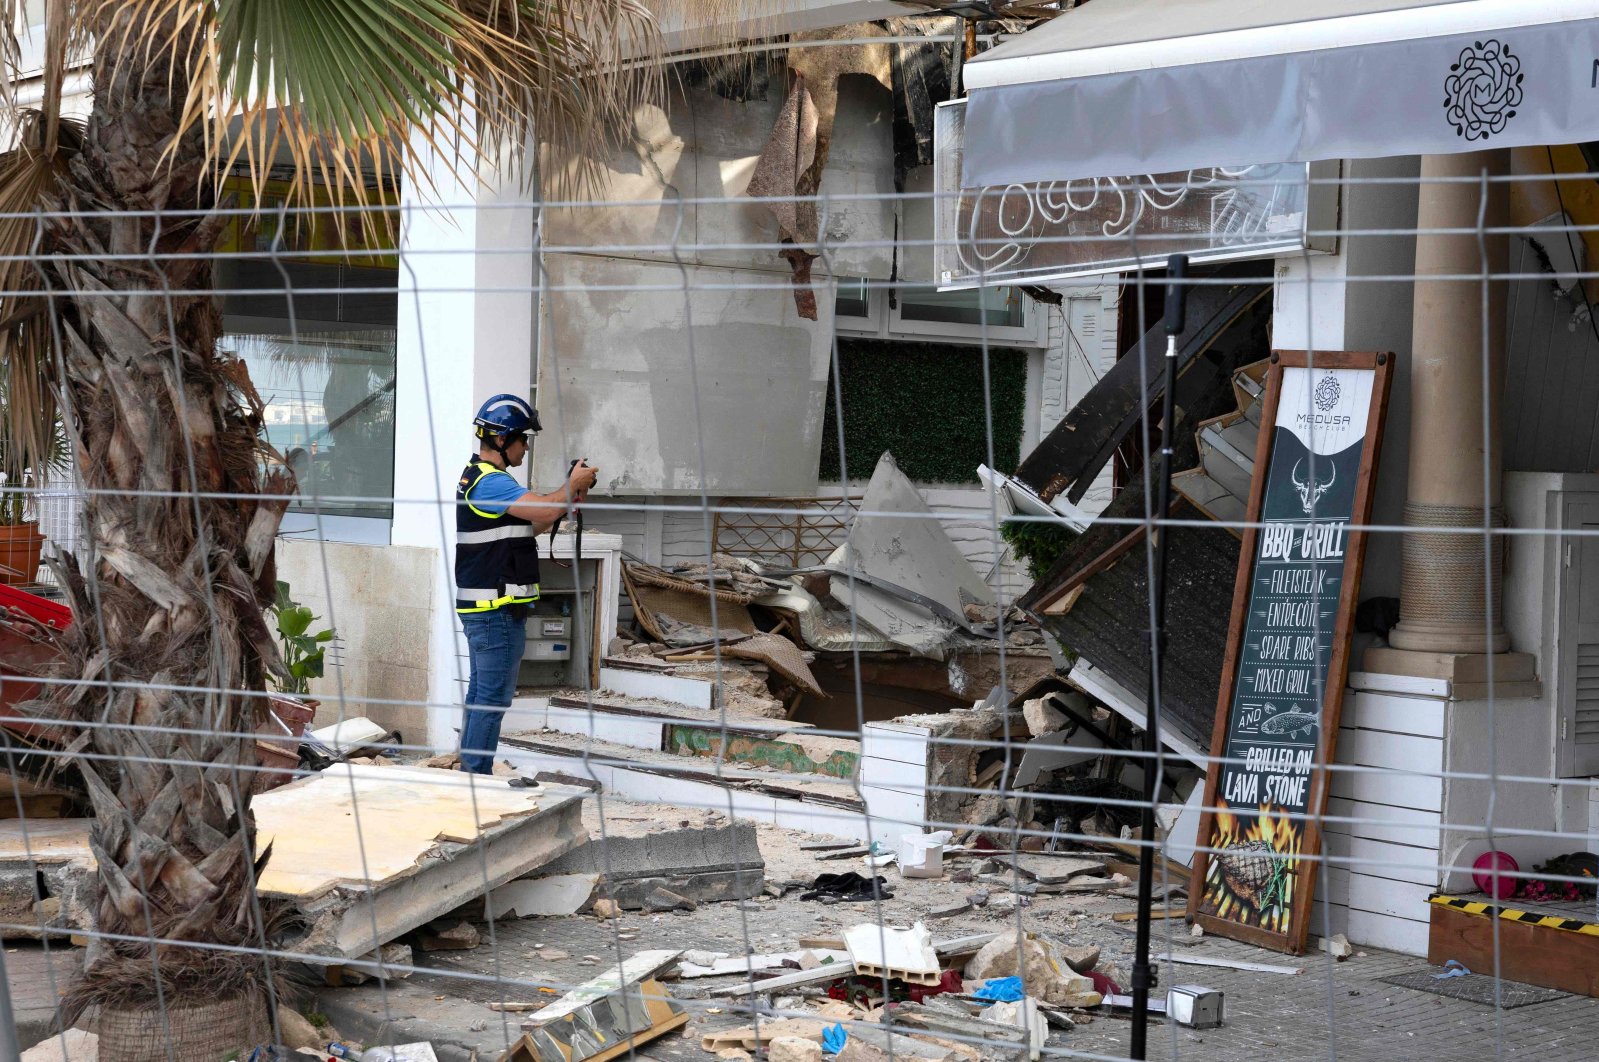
[822,339,1027,483]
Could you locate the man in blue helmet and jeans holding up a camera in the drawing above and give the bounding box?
[456,395,600,774]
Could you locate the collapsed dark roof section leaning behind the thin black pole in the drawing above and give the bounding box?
[1011,264,1271,758]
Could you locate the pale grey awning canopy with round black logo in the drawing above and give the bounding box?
[961,0,1599,187]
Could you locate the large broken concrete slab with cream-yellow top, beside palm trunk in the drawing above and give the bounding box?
[253,765,587,963]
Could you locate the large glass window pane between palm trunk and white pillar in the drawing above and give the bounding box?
[217,328,395,520]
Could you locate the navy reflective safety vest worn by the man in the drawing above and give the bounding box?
[456,459,539,613]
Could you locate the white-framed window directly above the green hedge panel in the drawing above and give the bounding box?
[833,277,1044,347]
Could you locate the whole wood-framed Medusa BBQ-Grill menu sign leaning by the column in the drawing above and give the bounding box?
[1188,350,1393,953]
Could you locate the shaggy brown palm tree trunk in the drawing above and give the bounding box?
[45,5,286,1023]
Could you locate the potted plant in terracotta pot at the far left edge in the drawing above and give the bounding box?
[0,373,70,585]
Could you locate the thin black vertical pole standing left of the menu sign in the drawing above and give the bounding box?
[1129,254,1188,1059]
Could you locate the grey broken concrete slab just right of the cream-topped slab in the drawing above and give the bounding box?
[532,822,766,910]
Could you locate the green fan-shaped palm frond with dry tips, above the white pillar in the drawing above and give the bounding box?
[85,0,660,219]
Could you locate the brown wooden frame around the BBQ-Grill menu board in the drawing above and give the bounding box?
[1188,350,1394,955]
